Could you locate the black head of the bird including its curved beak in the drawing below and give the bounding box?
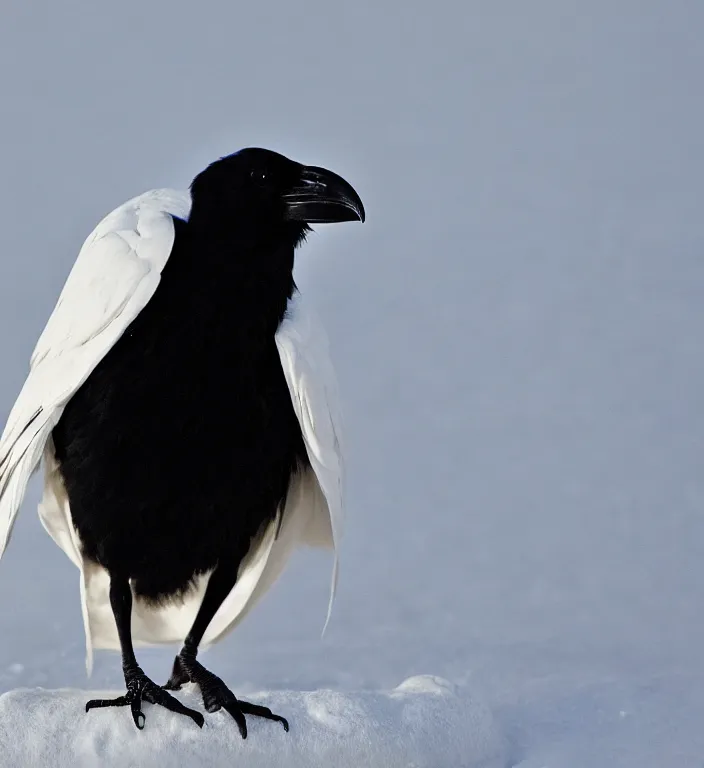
[191,143,365,240]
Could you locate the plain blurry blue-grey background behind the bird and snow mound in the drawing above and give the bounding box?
[0,0,704,768]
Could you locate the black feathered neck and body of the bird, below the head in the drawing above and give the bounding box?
[54,190,307,598]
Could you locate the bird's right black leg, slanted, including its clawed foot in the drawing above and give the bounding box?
[164,565,288,739]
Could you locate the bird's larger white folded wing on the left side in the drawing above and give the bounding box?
[0,190,190,555]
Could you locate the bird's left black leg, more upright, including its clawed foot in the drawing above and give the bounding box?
[86,575,204,730]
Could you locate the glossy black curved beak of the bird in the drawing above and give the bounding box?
[283,165,364,224]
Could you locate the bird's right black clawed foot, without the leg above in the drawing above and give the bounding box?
[164,656,288,739]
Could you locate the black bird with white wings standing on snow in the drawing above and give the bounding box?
[0,147,365,738]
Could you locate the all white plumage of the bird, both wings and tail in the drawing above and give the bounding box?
[0,189,344,669]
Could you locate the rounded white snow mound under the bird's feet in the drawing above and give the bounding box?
[0,675,505,768]
